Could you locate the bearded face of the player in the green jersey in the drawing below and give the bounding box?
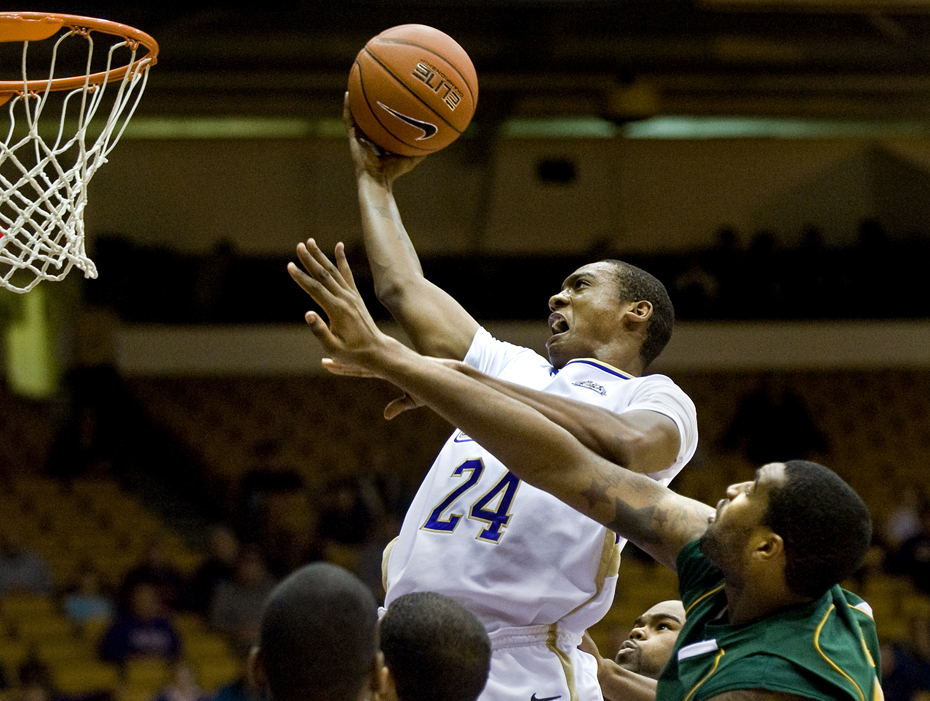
[701,462,785,578]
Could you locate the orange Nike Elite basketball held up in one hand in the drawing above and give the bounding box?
[349,24,478,156]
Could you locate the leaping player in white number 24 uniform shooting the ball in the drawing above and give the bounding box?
[330,97,697,701]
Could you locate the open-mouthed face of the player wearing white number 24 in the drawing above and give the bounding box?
[546,262,633,368]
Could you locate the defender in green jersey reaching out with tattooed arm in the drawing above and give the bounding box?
[288,240,882,701]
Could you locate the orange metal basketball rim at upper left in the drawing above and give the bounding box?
[0,12,158,98]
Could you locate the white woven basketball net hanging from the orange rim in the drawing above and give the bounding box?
[0,23,154,293]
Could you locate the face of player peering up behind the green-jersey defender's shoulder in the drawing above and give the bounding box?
[614,601,685,679]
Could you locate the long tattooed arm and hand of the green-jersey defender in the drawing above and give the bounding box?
[288,241,713,569]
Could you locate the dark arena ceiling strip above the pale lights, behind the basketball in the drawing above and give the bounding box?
[23,0,930,122]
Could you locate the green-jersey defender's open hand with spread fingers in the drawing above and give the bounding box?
[287,239,397,376]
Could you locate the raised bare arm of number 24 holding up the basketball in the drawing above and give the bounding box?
[343,96,478,360]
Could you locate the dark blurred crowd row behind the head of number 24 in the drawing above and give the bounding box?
[87,219,930,323]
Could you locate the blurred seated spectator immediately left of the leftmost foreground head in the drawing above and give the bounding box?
[209,545,275,650]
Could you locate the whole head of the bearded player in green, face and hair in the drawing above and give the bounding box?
[701,460,872,598]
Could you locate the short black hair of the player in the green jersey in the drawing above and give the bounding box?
[764,460,872,597]
